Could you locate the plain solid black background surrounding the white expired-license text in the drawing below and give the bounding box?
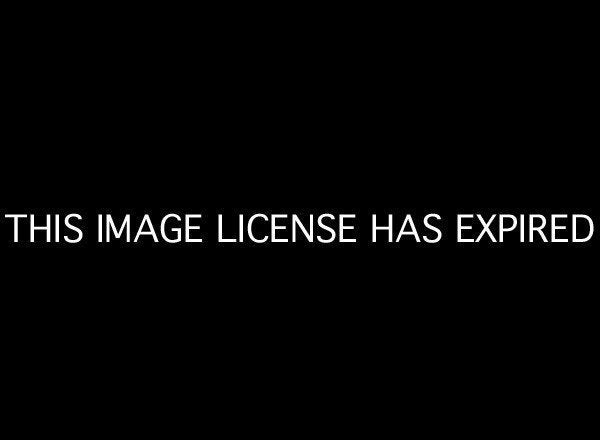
[1,5,598,433]
